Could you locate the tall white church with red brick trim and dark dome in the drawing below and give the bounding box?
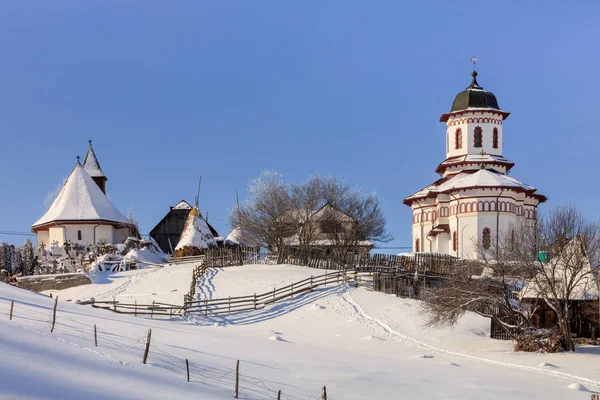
[404,66,546,259]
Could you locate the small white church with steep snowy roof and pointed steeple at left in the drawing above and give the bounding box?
[31,140,135,246]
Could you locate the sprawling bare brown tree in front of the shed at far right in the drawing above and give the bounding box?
[426,205,600,350]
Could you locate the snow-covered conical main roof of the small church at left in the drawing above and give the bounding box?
[33,163,129,227]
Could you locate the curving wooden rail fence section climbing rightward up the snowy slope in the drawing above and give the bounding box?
[183,271,348,316]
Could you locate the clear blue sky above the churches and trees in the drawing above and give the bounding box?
[0,0,600,252]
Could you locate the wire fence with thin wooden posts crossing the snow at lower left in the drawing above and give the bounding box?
[0,299,334,400]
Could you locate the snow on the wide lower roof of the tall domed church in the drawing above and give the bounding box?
[406,169,536,200]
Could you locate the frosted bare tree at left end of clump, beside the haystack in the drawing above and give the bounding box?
[229,171,298,260]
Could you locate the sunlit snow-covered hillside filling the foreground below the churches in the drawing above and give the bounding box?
[0,265,600,400]
